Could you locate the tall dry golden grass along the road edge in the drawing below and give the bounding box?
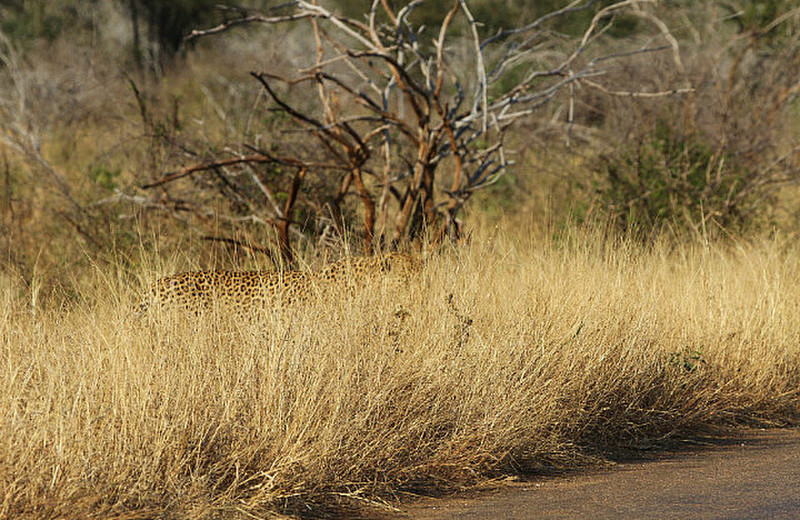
[0,233,800,519]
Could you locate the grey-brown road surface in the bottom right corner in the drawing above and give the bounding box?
[383,430,800,520]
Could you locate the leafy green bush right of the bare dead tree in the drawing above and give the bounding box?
[595,123,759,237]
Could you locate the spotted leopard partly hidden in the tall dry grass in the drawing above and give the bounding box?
[139,253,422,315]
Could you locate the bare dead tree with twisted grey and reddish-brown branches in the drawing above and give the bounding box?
[139,0,690,263]
